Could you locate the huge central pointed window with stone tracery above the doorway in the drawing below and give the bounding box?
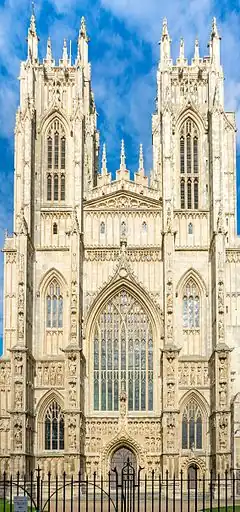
[93,290,153,411]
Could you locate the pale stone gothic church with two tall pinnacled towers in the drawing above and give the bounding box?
[0,14,240,476]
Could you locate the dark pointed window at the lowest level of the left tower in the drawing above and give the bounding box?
[44,401,64,450]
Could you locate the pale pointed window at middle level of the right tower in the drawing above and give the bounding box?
[183,279,200,329]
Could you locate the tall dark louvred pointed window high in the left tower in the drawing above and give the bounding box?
[46,119,66,202]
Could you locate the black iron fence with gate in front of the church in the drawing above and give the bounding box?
[0,461,240,512]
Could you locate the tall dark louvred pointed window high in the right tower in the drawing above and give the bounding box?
[179,118,199,210]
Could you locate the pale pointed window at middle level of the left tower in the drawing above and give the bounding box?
[46,279,63,329]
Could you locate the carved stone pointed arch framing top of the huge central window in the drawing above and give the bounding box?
[85,278,162,346]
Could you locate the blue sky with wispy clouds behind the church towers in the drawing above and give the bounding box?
[0,0,240,353]
